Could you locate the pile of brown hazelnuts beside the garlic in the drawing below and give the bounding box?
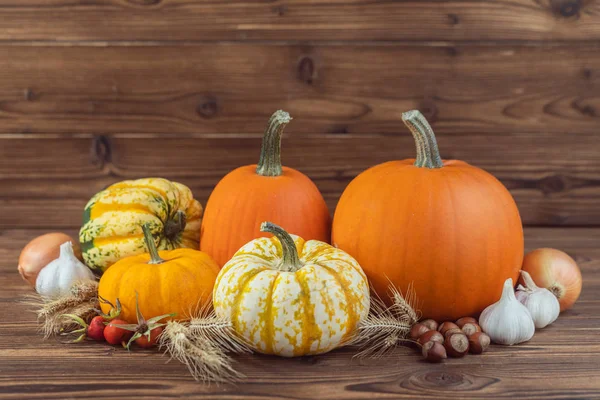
[410,317,490,362]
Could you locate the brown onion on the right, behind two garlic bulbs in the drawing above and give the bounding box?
[521,248,581,312]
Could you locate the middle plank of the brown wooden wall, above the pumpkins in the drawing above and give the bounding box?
[0,43,600,135]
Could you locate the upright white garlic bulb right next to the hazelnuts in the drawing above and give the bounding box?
[479,278,535,345]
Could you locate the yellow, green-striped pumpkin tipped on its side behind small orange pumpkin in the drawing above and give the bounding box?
[79,178,203,272]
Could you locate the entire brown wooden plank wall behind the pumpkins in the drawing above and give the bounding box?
[0,0,600,228]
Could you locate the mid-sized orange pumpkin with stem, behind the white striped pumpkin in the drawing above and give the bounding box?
[200,110,331,267]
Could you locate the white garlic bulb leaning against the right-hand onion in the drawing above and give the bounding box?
[515,271,560,328]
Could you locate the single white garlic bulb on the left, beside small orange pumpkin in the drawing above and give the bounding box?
[35,242,95,299]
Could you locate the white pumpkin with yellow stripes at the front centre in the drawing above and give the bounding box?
[213,222,370,357]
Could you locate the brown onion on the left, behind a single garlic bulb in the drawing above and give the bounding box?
[18,232,81,287]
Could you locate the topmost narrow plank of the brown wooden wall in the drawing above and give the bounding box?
[0,0,600,41]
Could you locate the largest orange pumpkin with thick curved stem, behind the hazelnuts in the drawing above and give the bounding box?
[332,110,523,321]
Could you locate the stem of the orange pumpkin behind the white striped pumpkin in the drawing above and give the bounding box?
[256,110,292,176]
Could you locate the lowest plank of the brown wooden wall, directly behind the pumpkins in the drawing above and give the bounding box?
[0,129,600,228]
